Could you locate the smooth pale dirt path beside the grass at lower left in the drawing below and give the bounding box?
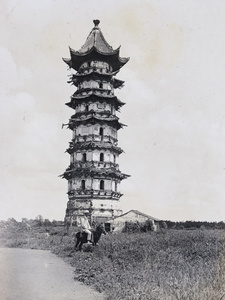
[0,248,104,300]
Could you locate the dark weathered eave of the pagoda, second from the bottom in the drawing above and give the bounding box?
[66,140,123,155]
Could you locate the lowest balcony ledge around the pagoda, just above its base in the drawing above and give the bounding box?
[67,189,123,199]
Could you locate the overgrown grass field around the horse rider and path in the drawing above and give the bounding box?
[0,219,225,300]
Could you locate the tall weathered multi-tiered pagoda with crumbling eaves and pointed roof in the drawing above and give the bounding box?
[62,20,129,224]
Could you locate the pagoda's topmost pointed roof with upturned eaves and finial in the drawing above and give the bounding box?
[63,20,129,71]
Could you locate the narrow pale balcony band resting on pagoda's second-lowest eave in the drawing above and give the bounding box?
[69,134,118,147]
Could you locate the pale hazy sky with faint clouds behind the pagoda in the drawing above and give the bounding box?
[0,0,225,221]
